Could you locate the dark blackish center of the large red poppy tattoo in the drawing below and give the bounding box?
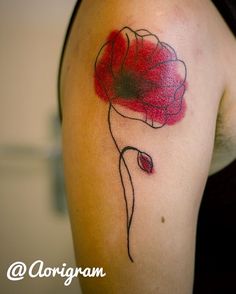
[114,71,141,99]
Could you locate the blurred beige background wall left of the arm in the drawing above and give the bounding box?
[0,0,80,294]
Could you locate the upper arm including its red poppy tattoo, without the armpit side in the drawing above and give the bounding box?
[61,1,222,293]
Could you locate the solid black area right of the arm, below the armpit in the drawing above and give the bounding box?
[194,160,236,294]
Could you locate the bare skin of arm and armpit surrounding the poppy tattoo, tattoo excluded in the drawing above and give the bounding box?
[61,0,236,294]
